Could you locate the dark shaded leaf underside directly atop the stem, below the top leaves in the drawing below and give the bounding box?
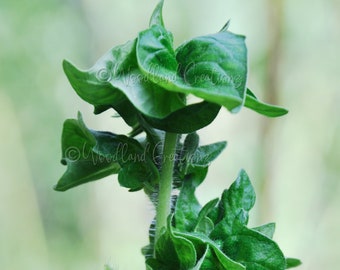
[146,101,221,134]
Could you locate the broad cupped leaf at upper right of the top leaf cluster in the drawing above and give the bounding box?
[176,32,247,112]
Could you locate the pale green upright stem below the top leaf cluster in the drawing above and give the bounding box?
[155,132,177,241]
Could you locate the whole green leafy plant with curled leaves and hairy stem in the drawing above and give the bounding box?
[55,1,300,270]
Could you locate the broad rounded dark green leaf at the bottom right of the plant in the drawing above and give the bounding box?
[223,226,286,270]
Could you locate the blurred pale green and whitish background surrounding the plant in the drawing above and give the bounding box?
[0,0,340,270]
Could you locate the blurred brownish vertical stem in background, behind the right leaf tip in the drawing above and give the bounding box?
[258,0,284,222]
